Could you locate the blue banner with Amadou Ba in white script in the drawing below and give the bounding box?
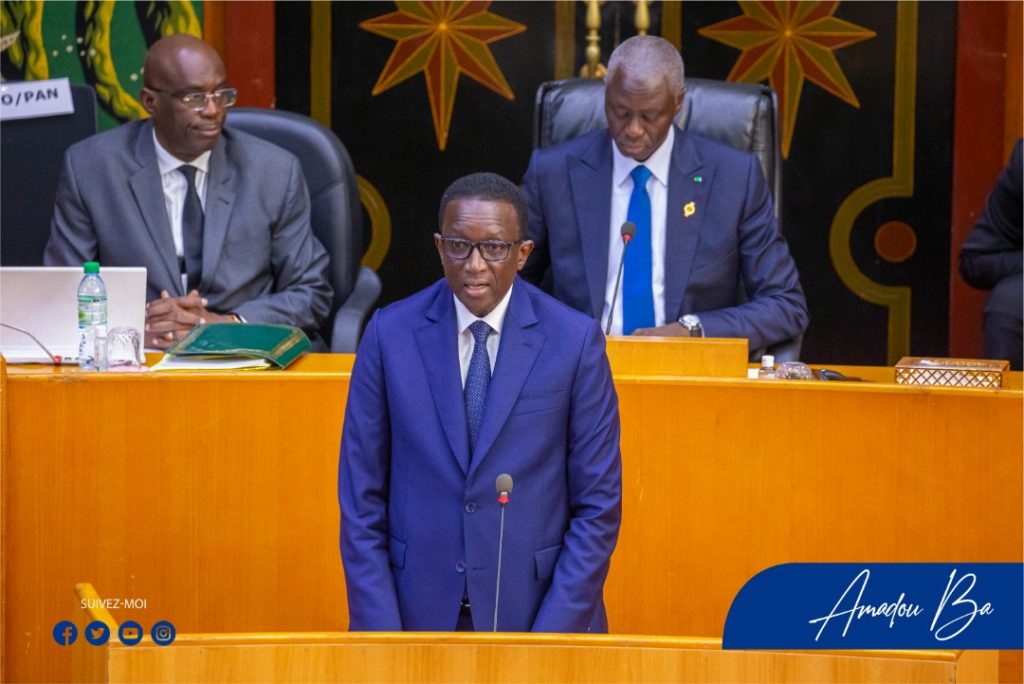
[722,563,1024,650]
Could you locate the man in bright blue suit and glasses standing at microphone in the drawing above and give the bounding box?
[338,173,622,632]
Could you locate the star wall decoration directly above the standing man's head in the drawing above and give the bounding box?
[359,0,526,149]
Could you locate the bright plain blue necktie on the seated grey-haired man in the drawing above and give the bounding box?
[623,165,654,335]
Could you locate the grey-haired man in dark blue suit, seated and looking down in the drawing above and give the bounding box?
[523,36,808,356]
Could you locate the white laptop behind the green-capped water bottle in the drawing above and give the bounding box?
[0,266,145,364]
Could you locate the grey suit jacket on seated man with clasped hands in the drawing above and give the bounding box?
[43,117,332,335]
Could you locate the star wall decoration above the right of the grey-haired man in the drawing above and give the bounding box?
[697,0,876,157]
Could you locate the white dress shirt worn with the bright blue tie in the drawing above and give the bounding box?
[601,126,676,335]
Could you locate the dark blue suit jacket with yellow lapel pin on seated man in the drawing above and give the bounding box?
[523,128,808,349]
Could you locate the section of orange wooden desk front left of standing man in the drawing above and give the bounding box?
[3,354,354,682]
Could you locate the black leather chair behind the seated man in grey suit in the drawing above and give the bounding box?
[227,108,381,352]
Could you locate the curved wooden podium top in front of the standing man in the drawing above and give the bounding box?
[76,633,997,684]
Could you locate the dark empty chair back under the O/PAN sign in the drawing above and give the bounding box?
[0,85,96,266]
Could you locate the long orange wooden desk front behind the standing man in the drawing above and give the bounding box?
[0,355,1024,681]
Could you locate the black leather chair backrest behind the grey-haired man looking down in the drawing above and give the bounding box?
[534,78,782,220]
